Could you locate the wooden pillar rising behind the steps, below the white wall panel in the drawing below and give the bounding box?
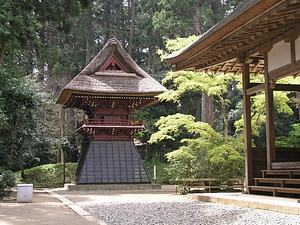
[265,53,275,170]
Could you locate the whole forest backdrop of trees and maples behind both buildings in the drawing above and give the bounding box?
[0,0,300,182]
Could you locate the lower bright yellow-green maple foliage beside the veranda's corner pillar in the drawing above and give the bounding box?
[150,114,244,179]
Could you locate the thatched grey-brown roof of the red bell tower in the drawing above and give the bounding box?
[56,38,166,104]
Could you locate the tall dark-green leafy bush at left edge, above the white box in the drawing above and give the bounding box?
[0,69,40,169]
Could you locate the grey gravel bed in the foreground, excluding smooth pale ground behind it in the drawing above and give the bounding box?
[83,202,300,225]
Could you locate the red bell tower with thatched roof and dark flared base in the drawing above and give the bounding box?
[57,39,166,184]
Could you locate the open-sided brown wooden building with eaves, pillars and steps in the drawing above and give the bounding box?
[165,0,300,195]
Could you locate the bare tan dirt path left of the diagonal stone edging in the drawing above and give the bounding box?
[0,190,98,225]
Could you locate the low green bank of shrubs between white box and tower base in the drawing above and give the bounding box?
[16,163,77,188]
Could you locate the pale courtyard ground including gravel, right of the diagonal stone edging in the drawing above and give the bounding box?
[55,192,300,225]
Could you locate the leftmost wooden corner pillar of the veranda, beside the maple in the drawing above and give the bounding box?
[243,63,254,190]
